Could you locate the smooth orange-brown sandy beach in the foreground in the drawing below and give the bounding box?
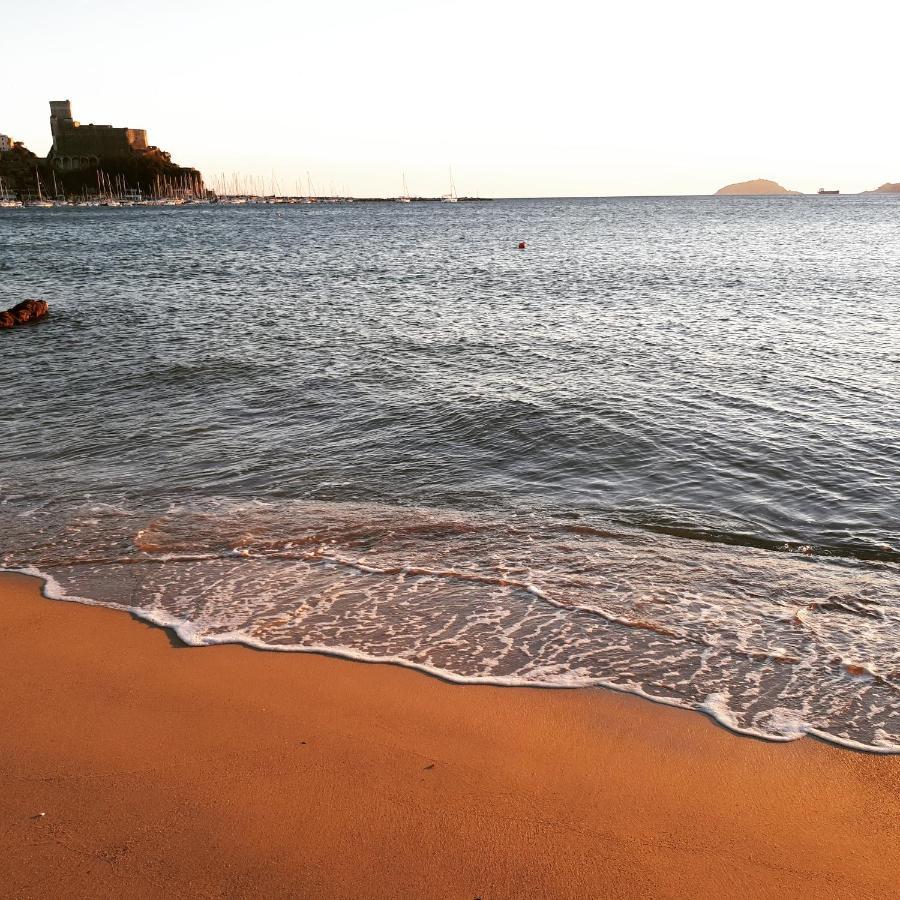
[0,575,900,900]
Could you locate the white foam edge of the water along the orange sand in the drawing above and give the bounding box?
[0,557,900,756]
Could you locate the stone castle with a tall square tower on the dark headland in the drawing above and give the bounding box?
[47,100,158,172]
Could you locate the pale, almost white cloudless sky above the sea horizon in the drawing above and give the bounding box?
[0,0,900,196]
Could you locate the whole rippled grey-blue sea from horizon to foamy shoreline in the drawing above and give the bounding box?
[0,197,900,751]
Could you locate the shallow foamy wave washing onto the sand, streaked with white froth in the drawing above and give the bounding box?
[3,501,900,752]
